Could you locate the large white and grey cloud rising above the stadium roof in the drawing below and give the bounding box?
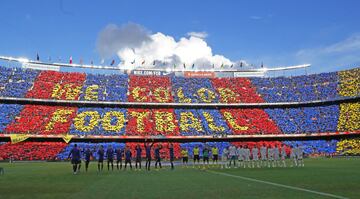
[97,24,248,68]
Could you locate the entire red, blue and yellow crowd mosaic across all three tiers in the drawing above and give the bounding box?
[0,67,360,159]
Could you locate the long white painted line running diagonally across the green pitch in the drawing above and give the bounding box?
[207,171,348,199]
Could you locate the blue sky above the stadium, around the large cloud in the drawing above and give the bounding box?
[0,0,360,72]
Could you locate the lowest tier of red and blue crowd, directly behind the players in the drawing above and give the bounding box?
[0,139,354,160]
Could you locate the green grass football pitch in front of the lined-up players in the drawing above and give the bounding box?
[0,158,360,199]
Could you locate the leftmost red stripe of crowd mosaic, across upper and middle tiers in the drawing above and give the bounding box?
[5,71,85,134]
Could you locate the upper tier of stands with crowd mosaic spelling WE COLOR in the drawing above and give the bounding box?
[0,67,360,103]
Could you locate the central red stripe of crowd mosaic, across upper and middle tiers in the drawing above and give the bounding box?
[126,76,179,135]
